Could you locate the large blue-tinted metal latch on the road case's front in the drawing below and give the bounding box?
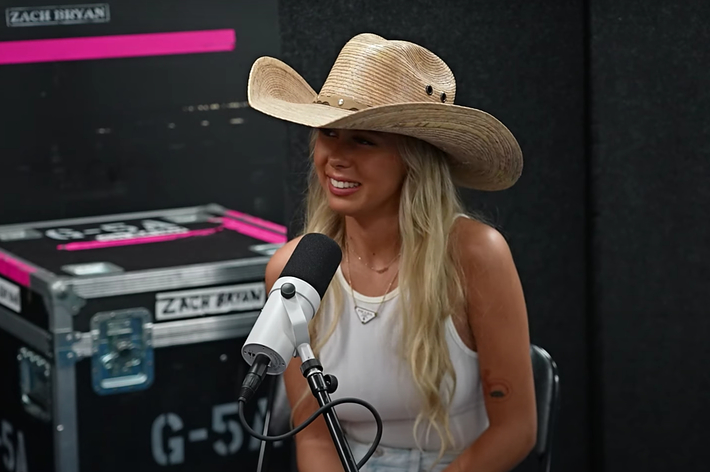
[91,308,153,395]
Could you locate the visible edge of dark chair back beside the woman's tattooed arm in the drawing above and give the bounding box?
[530,344,560,472]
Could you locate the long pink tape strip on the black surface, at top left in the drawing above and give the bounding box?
[0,29,236,64]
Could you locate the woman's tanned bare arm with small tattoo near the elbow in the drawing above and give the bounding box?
[446,221,537,472]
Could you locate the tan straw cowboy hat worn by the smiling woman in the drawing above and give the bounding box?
[247,34,523,190]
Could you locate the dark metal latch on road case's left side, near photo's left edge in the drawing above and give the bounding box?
[17,347,52,421]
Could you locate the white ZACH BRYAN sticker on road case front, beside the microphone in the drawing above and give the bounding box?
[155,282,266,320]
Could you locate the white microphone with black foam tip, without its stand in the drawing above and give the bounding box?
[239,233,342,402]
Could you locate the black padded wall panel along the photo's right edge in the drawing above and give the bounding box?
[592,0,710,472]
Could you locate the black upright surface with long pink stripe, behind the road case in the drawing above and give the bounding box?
[0,0,286,224]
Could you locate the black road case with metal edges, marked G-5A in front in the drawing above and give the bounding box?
[0,204,291,472]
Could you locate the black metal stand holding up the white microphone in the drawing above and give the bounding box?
[298,343,359,472]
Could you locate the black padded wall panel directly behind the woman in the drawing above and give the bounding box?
[280,0,589,472]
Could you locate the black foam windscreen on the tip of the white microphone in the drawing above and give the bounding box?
[281,233,343,299]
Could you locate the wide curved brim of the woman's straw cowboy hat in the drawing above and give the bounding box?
[247,57,523,190]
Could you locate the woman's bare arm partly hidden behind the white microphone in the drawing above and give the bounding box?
[265,238,343,472]
